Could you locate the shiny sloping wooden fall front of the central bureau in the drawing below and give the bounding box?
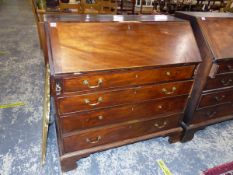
[47,15,201,74]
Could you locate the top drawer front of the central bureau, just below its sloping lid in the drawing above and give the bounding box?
[61,65,195,93]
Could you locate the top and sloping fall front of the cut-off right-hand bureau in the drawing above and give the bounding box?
[176,12,233,60]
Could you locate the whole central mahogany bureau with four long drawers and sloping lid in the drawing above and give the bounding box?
[43,15,201,171]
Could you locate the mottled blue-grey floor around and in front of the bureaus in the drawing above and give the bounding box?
[0,0,233,175]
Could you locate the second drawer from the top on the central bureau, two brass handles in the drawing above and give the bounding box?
[57,81,193,114]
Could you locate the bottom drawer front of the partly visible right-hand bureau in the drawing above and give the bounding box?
[192,103,233,123]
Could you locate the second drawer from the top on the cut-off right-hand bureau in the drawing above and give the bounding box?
[205,73,233,90]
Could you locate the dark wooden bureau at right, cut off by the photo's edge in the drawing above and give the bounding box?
[176,12,233,141]
